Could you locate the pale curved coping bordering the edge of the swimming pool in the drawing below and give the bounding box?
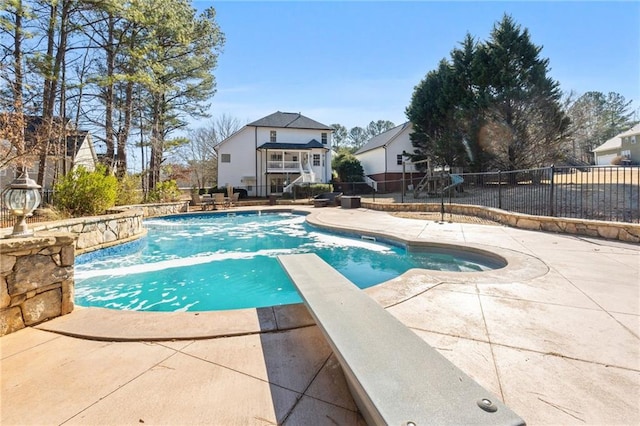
[35,206,549,341]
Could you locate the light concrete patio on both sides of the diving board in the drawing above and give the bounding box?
[0,208,640,425]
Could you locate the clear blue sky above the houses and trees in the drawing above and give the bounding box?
[194,1,640,128]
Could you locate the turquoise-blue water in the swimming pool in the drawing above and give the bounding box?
[75,213,493,311]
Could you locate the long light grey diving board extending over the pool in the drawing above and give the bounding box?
[278,253,525,426]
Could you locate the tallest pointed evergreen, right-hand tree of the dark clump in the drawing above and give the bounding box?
[478,15,569,170]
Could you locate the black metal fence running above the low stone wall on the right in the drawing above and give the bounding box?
[364,166,640,223]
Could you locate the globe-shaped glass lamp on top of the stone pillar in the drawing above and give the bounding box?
[2,170,41,238]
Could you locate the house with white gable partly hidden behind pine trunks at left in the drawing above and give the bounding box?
[0,116,98,190]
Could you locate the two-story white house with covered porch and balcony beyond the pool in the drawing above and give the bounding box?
[216,111,333,196]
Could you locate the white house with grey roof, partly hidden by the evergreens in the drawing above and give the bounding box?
[355,121,419,192]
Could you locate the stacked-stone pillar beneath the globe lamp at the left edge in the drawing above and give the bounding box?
[0,233,75,336]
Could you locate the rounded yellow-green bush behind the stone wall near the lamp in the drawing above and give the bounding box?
[54,164,118,217]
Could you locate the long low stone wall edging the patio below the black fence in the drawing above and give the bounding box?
[362,201,640,243]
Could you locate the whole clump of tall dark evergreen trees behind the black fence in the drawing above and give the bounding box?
[406,15,569,170]
